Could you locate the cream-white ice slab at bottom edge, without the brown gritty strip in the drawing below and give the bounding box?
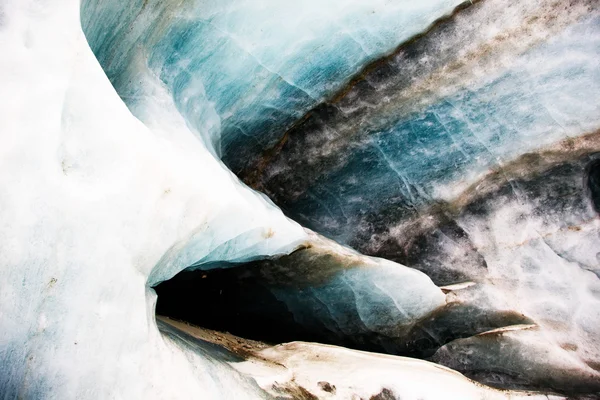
[236,342,562,400]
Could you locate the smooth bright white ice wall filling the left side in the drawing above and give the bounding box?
[0,0,305,399]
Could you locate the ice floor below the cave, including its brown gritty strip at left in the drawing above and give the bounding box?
[159,318,564,400]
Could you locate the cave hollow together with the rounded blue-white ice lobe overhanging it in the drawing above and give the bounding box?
[155,233,446,353]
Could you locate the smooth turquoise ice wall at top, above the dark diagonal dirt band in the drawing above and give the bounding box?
[82,0,461,173]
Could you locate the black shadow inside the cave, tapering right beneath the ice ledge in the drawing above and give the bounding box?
[154,260,532,358]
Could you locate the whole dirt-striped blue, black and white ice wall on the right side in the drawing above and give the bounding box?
[234,0,600,391]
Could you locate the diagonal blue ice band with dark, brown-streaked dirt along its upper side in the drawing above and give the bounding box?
[250,0,600,247]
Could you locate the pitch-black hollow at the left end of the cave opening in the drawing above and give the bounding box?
[154,263,324,345]
